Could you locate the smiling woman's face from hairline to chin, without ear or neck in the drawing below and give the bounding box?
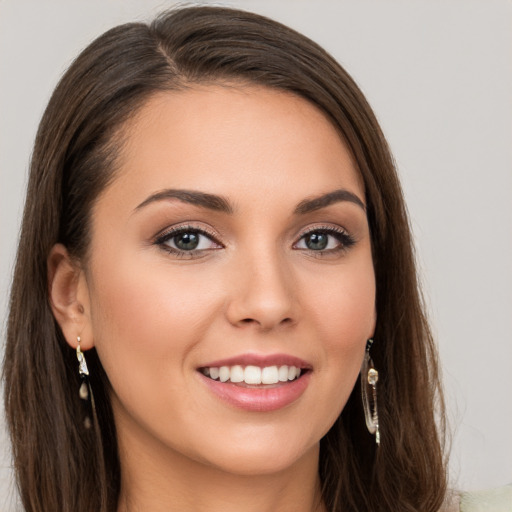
[81,86,375,474]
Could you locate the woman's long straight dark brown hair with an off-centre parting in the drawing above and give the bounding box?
[4,7,446,512]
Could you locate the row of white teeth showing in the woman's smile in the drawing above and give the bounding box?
[201,365,301,384]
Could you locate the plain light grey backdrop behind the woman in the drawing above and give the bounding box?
[0,0,512,510]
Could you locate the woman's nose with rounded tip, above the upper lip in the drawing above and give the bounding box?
[226,247,298,331]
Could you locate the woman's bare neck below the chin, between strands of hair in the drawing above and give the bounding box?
[118,418,325,512]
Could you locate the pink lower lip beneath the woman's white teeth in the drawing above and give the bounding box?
[198,372,311,412]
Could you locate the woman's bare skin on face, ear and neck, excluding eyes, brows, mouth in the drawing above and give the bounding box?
[49,85,375,512]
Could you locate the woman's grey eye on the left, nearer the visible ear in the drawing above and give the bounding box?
[155,226,222,256]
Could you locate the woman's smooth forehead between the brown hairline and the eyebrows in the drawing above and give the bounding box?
[100,85,364,212]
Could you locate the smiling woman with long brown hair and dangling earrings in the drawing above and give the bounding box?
[5,7,446,511]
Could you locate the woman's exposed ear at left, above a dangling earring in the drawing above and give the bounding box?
[47,244,94,350]
